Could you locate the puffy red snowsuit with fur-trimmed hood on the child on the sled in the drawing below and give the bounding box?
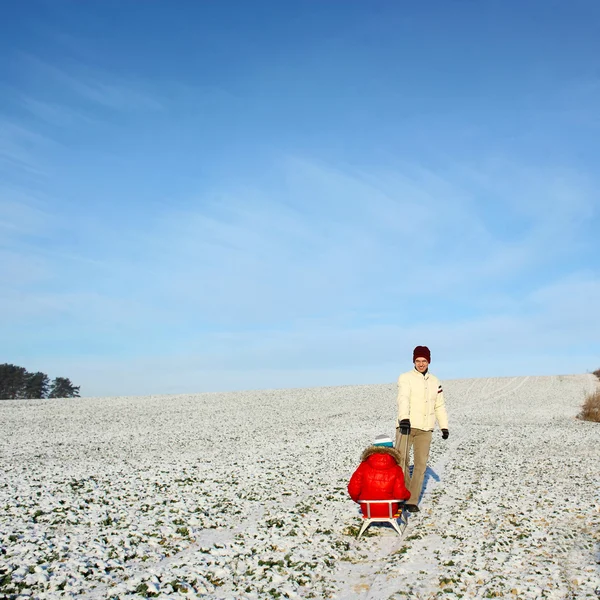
[348,446,410,517]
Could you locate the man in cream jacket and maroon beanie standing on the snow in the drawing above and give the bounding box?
[396,346,449,512]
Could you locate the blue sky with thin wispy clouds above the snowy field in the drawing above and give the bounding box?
[0,0,600,396]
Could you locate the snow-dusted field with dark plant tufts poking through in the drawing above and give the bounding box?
[0,375,600,599]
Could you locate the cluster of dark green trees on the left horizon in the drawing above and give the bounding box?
[0,363,80,400]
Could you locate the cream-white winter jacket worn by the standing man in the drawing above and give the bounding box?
[398,369,448,431]
